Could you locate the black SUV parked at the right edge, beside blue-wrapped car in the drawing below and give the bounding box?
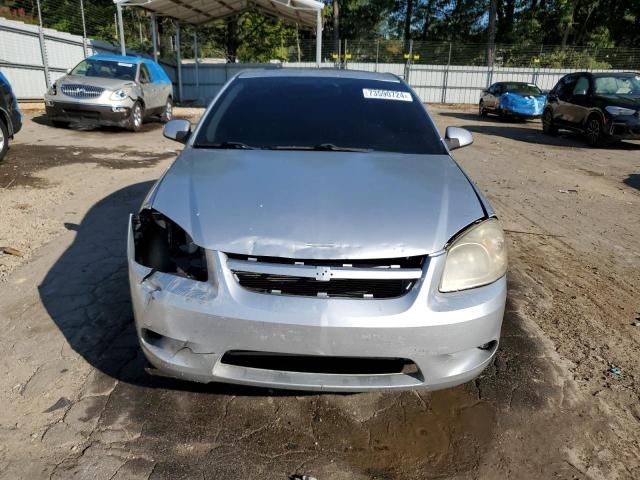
[542,72,640,147]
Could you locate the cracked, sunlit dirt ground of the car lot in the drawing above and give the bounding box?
[0,106,640,480]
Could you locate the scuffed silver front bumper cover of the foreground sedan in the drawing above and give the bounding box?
[127,216,506,391]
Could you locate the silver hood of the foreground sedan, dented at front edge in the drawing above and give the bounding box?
[147,148,484,259]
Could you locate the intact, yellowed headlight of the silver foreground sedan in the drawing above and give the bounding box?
[440,218,507,292]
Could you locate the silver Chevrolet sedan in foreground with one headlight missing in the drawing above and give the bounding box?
[128,69,507,391]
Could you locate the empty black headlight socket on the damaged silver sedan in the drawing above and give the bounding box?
[133,209,208,282]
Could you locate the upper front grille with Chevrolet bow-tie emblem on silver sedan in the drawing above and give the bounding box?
[227,254,426,299]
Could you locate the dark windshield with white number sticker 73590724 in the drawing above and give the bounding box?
[194,77,445,154]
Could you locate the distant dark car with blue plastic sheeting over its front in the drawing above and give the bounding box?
[478,82,547,119]
